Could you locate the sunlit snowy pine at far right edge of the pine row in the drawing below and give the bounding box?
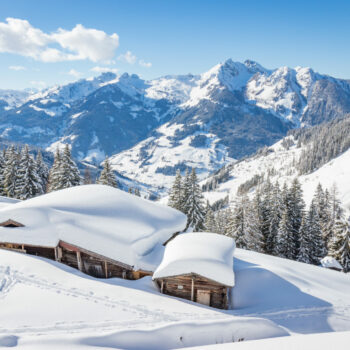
[328,216,350,272]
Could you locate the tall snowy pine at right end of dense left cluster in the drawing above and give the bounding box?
[58,144,81,189]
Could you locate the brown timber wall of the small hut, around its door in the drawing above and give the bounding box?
[156,275,228,309]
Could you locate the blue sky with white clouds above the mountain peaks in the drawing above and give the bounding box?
[0,0,350,89]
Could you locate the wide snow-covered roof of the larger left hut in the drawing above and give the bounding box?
[0,185,187,270]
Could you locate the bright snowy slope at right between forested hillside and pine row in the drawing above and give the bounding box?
[203,136,350,210]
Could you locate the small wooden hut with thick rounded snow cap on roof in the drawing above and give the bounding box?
[153,232,235,309]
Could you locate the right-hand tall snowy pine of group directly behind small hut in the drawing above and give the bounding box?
[185,168,205,231]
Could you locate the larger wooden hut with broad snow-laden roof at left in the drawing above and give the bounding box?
[0,185,186,279]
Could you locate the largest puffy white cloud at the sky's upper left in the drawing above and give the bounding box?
[0,18,119,62]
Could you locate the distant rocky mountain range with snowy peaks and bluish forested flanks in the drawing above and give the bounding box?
[0,59,350,191]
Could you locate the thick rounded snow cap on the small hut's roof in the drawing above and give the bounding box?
[153,232,235,287]
